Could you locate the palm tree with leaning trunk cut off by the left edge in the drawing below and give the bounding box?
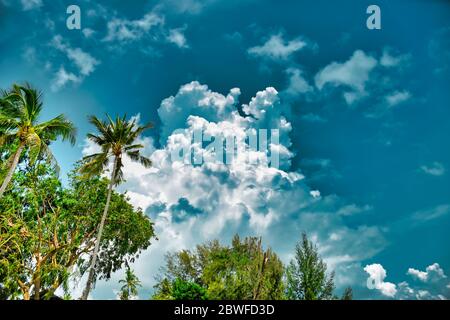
[0,84,76,198]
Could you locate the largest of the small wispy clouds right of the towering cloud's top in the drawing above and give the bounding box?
[315,50,378,104]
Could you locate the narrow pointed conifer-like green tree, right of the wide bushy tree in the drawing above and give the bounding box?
[286,233,334,300]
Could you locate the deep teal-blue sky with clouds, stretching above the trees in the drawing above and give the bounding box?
[0,0,450,298]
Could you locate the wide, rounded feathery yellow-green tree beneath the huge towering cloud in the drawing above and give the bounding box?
[154,236,284,300]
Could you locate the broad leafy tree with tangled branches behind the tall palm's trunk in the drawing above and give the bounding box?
[0,163,154,299]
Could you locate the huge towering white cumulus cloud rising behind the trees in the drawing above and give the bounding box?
[77,81,386,298]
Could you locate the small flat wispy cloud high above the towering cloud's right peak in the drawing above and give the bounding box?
[248,33,307,60]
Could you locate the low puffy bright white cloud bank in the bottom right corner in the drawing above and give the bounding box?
[364,263,450,300]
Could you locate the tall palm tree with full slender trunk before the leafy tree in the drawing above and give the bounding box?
[80,116,152,300]
